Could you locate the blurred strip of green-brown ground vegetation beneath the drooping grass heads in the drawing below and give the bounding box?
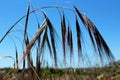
[0,64,120,80]
